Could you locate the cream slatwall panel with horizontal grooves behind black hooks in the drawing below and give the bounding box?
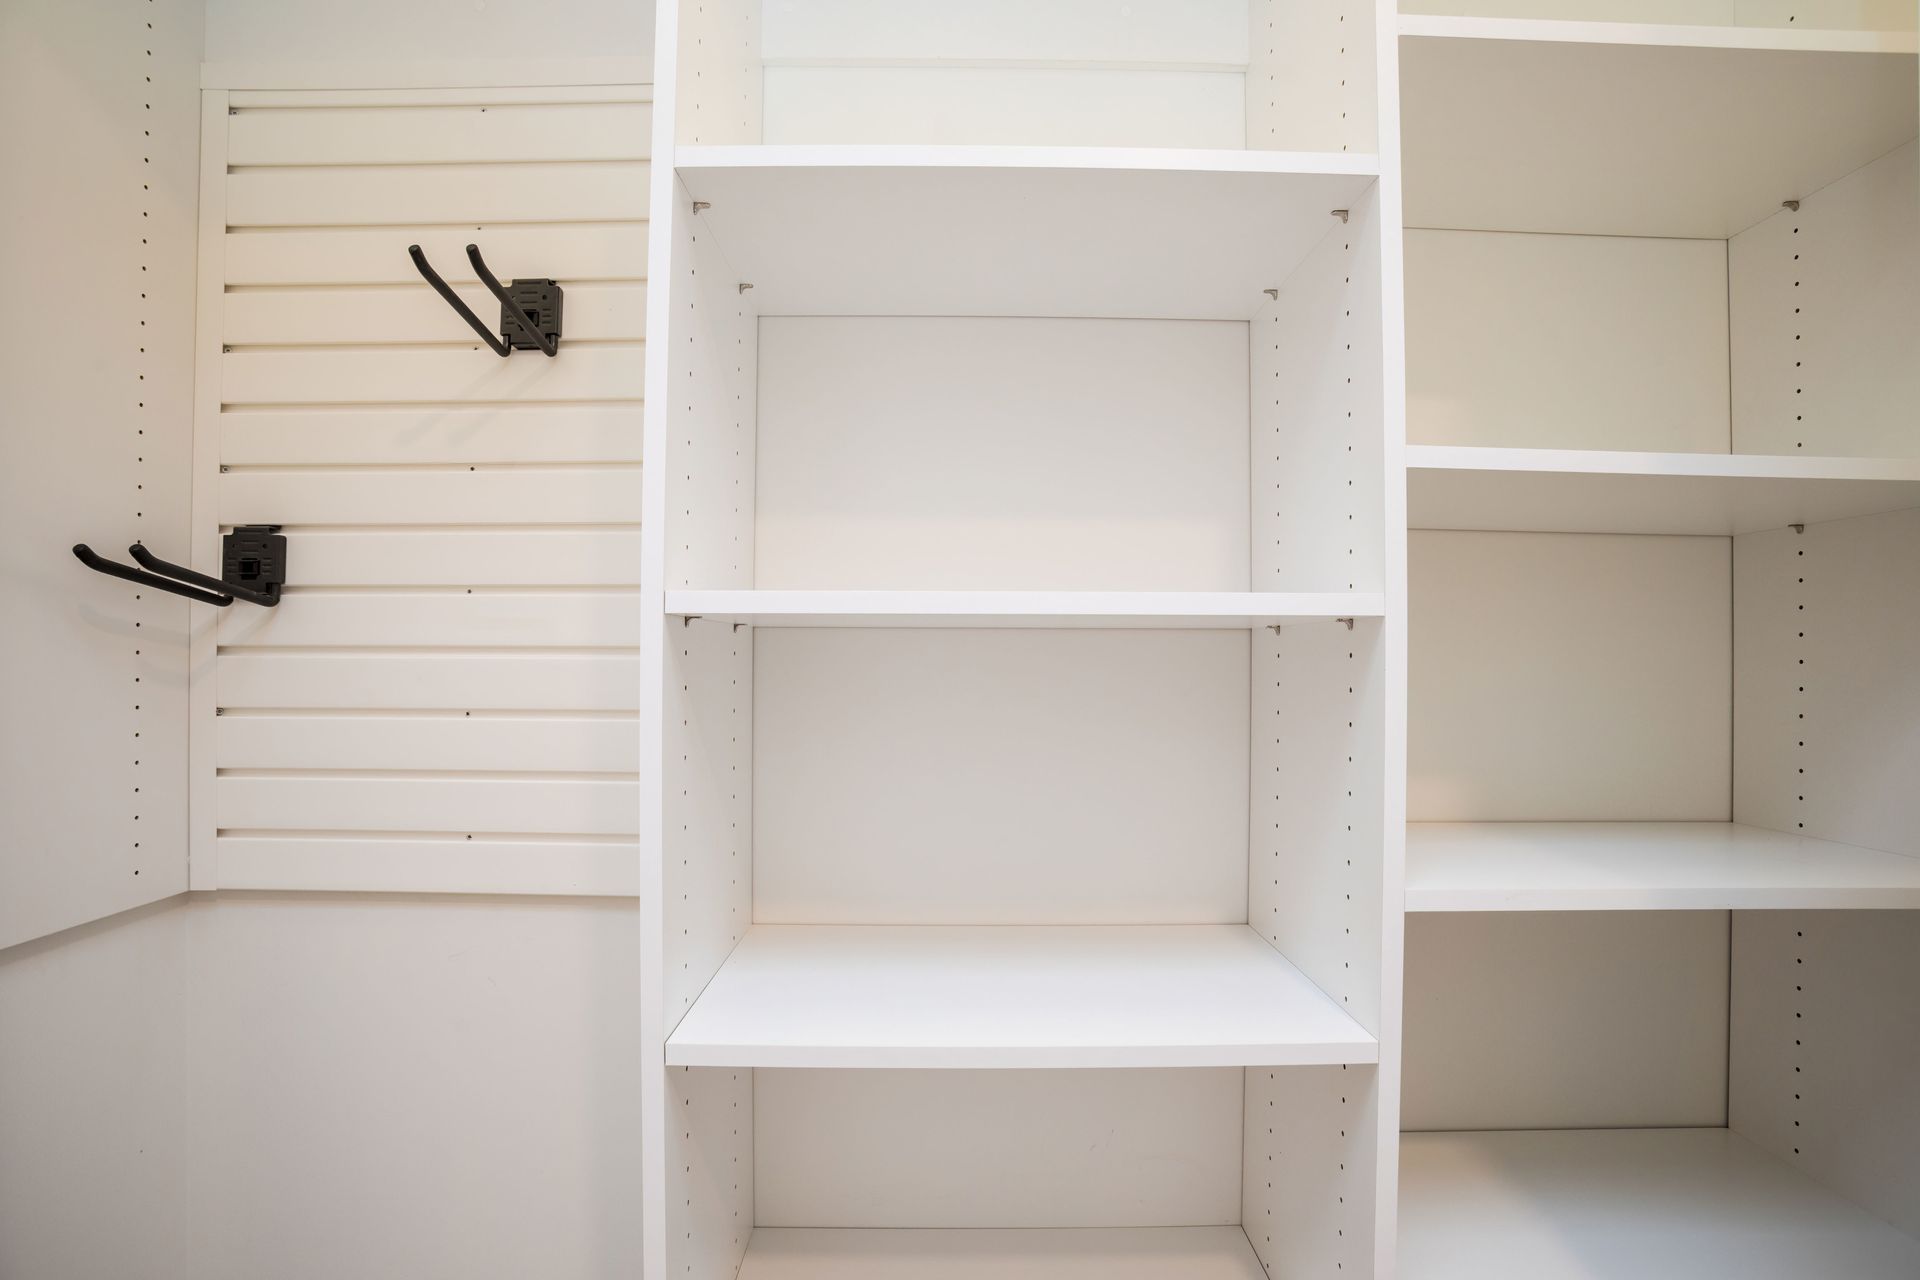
[196,86,653,894]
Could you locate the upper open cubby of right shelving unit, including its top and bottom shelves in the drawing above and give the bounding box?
[1402,6,1920,533]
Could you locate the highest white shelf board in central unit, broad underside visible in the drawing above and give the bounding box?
[676,146,1379,320]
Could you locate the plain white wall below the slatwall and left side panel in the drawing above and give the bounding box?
[0,894,639,1280]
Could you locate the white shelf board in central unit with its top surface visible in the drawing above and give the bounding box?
[666,925,1379,1069]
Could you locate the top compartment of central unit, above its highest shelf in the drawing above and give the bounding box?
[678,0,1377,154]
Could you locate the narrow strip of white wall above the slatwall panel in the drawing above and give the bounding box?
[205,0,653,61]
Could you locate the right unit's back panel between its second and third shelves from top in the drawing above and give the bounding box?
[1407,532,1732,821]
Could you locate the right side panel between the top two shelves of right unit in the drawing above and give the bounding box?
[1730,144,1920,457]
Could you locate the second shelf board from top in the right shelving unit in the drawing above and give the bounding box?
[1407,445,1920,533]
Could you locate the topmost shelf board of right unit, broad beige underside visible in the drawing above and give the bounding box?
[1400,17,1920,240]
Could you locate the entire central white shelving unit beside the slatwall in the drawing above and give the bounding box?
[641,0,1405,1280]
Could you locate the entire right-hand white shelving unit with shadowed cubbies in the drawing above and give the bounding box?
[1398,0,1920,1280]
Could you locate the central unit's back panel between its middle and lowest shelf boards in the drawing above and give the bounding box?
[756,624,1251,925]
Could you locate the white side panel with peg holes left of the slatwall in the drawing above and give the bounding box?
[0,0,207,946]
